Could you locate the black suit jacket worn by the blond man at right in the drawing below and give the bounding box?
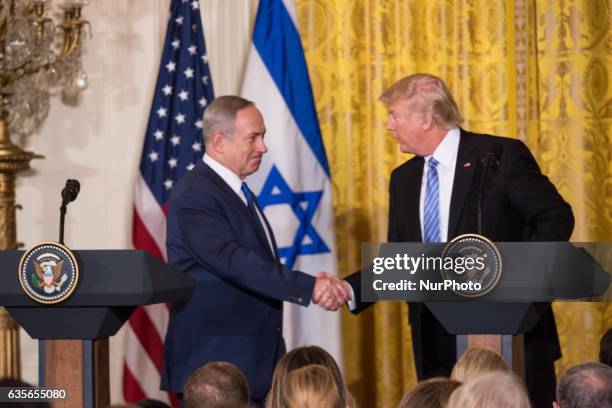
[347,129,574,371]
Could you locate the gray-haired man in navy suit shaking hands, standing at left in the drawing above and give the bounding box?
[162,95,350,405]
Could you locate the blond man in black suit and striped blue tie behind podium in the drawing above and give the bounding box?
[347,74,574,407]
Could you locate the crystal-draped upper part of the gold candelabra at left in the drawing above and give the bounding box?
[0,0,91,136]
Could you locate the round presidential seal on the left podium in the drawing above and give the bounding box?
[19,242,79,304]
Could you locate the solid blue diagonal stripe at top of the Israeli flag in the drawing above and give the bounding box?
[253,0,330,177]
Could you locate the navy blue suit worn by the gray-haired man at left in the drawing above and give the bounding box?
[162,162,315,399]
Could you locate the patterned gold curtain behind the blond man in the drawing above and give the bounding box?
[297,0,612,408]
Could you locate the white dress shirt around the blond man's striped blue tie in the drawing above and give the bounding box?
[419,128,460,242]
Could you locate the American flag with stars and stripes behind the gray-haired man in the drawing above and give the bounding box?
[123,0,214,407]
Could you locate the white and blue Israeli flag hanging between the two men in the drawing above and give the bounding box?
[241,0,342,364]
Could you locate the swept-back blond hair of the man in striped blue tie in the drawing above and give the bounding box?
[379,74,461,129]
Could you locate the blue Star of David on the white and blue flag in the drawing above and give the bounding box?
[257,166,330,269]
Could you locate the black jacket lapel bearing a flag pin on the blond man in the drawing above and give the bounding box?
[448,129,479,240]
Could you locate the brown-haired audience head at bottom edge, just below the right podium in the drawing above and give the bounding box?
[397,377,461,408]
